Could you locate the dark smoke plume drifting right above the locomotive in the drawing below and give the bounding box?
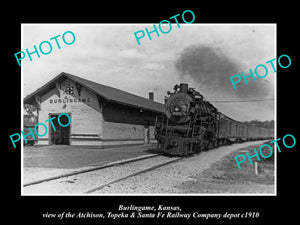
[175,45,267,99]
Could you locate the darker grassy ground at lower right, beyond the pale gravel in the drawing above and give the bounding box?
[178,142,274,194]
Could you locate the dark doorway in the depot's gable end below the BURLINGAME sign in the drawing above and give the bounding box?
[49,114,71,145]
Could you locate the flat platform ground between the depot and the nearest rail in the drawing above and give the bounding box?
[23,144,156,184]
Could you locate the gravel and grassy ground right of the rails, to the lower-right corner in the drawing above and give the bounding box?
[95,141,275,195]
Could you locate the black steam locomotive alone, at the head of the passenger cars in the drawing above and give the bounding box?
[155,84,218,156]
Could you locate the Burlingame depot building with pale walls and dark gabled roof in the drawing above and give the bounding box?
[24,72,164,145]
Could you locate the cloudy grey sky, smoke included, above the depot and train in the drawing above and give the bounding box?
[22,24,276,121]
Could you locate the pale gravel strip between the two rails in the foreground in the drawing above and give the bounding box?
[23,155,181,194]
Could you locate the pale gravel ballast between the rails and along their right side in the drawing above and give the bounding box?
[23,141,272,195]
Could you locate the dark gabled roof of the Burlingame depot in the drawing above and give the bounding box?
[24,72,164,113]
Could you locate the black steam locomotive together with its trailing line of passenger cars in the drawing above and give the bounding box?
[154,84,274,156]
